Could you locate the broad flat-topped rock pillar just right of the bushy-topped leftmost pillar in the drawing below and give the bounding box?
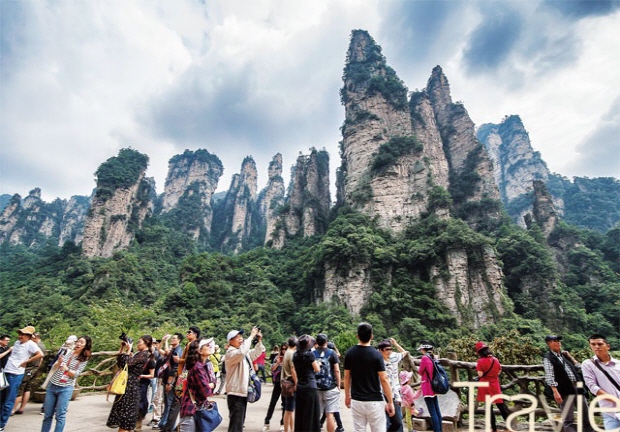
[161,149,224,243]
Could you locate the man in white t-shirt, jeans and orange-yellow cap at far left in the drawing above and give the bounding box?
[0,326,43,432]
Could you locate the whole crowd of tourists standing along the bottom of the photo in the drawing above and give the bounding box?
[0,323,620,432]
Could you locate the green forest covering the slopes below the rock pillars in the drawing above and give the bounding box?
[0,200,620,361]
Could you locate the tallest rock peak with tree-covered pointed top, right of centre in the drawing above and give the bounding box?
[337,30,429,231]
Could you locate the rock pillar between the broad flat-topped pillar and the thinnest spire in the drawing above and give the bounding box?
[219,156,258,253]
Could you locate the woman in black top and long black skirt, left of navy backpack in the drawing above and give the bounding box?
[293,335,321,432]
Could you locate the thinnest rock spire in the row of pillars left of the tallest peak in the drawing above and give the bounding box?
[258,153,285,244]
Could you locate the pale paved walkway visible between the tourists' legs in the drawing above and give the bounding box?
[5,385,353,432]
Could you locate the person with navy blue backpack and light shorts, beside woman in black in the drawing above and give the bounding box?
[314,333,340,432]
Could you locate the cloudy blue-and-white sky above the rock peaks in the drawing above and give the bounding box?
[0,0,620,201]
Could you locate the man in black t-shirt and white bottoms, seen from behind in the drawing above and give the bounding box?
[344,323,394,432]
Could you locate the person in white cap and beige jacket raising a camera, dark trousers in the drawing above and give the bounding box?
[224,326,265,432]
